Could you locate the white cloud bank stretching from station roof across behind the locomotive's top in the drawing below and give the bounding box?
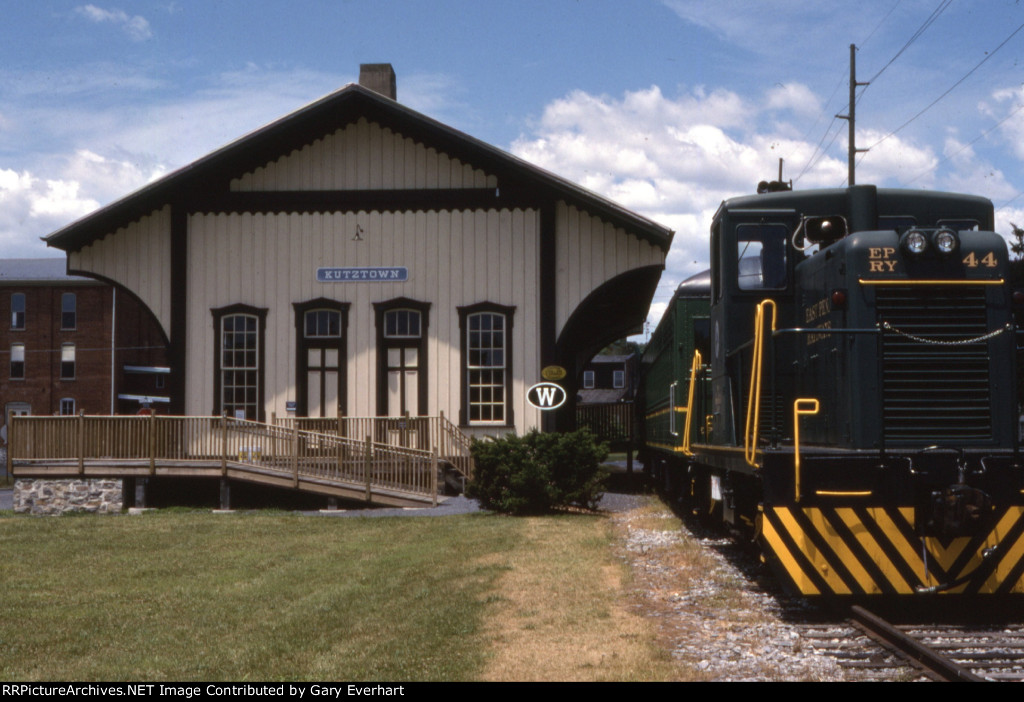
[511,76,1024,337]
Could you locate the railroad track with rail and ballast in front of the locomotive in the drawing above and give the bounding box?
[804,607,1024,682]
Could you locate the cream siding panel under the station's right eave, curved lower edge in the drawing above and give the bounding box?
[555,202,665,334]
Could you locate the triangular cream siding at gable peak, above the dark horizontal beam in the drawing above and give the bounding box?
[231,118,498,191]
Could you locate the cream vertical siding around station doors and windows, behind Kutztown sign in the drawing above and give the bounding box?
[185,210,540,433]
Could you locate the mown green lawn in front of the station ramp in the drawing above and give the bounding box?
[0,511,520,681]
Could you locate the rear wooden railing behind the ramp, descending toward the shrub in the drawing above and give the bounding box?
[270,412,473,479]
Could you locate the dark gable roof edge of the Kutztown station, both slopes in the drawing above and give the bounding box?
[44,84,674,252]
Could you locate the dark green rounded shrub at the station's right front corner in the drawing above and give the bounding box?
[466,429,608,515]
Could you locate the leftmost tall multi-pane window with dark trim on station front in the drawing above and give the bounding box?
[210,305,266,422]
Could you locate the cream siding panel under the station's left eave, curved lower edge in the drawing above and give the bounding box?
[68,207,171,338]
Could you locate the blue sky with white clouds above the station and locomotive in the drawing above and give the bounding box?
[0,0,1024,333]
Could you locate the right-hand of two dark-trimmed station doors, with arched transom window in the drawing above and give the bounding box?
[374,298,430,416]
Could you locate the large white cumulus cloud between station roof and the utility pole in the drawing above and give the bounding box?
[512,85,843,297]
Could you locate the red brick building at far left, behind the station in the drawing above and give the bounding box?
[0,258,169,425]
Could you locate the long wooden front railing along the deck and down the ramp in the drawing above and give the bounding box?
[7,415,438,500]
